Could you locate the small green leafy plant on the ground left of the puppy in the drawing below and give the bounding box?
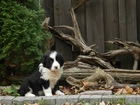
[3,84,19,96]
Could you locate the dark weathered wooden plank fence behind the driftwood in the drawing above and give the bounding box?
[43,0,140,68]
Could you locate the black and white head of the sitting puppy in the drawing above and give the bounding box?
[40,51,64,70]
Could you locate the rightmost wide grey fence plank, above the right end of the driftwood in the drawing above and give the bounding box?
[126,0,137,42]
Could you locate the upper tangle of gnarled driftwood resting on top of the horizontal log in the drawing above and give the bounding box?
[49,9,140,70]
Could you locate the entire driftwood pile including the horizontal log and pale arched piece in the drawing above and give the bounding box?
[41,7,140,87]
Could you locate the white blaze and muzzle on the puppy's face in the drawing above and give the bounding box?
[50,52,60,70]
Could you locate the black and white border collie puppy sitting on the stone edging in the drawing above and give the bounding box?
[18,51,64,97]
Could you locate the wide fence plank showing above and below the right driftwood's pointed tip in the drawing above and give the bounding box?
[104,0,119,51]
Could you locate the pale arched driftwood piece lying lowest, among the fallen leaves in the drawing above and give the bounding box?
[66,73,140,89]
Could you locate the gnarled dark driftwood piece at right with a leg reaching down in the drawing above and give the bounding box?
[100,39,140,70]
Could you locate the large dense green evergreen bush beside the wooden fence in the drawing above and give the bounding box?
[0,0,51,76]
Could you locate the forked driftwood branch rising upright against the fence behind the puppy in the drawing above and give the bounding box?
[49,8,96,55]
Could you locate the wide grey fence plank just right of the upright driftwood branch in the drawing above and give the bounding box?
[86,0,104,52]
